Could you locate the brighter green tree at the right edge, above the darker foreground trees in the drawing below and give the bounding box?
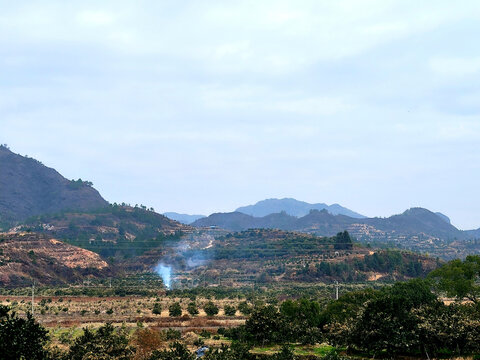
[429,255,480,304]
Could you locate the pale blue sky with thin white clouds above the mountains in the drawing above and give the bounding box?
[0,0,480,229]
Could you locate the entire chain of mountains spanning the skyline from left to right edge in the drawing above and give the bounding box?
[0,146,480,264]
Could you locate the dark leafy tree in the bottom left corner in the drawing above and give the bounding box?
[0,305,48,360]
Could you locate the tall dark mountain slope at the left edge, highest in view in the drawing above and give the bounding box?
[0,146,108,225]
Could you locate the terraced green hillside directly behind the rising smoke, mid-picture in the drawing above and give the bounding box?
[135,229,438,287]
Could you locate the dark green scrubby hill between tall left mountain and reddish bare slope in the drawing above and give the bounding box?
[13,204,190,258]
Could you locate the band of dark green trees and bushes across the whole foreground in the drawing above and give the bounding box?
[0,256,480,360]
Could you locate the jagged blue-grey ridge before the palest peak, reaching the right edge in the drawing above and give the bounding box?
[192,208,480,258]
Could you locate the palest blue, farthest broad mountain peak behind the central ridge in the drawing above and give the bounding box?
[235,198,366,219]
